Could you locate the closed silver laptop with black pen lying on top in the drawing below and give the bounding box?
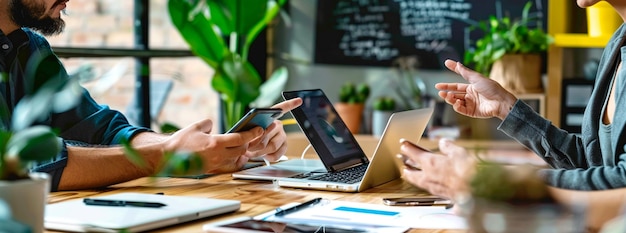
[44,193,241,232]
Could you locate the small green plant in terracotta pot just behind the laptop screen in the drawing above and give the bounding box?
[335,82,370,134]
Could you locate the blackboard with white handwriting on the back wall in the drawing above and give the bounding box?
[315,0,547,69]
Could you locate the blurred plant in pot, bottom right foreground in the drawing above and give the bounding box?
[458,161,585,232]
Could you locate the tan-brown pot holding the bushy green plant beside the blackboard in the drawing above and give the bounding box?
[489,54,543,94]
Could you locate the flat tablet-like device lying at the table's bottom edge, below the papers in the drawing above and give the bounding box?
[202,217,367,233]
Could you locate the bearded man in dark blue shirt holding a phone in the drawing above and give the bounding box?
[0,0,302,191]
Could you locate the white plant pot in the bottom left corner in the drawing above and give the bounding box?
[0,173,50,232]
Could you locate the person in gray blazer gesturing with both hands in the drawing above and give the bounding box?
[401,0,626,197]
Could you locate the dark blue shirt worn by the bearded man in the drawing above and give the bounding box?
[0,28,150,191]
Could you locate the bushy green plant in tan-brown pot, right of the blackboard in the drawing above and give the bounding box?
[464,2,554,94]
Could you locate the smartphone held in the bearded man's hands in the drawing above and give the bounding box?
[226,108,283,133]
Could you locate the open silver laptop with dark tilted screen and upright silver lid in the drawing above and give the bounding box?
[277,89,433,192]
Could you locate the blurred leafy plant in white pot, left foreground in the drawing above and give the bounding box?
[0,53,82,232]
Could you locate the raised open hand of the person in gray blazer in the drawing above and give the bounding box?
[435,60,517,120]
